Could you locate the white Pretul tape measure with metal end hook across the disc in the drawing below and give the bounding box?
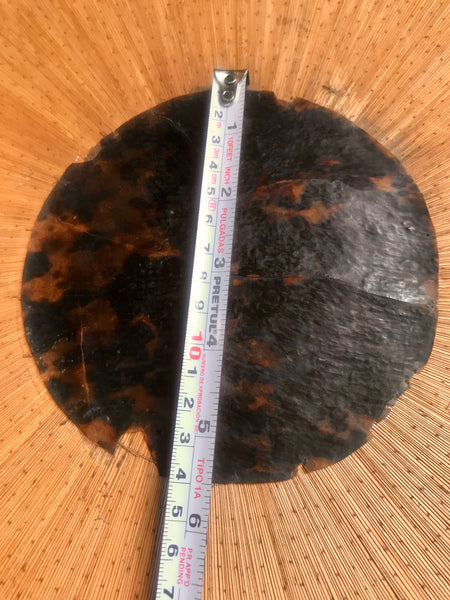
[156,70,247,600]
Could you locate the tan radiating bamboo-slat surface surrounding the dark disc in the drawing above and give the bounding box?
[0,0,450,600]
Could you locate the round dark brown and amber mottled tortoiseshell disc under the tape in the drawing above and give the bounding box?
[22,92,437,482]
